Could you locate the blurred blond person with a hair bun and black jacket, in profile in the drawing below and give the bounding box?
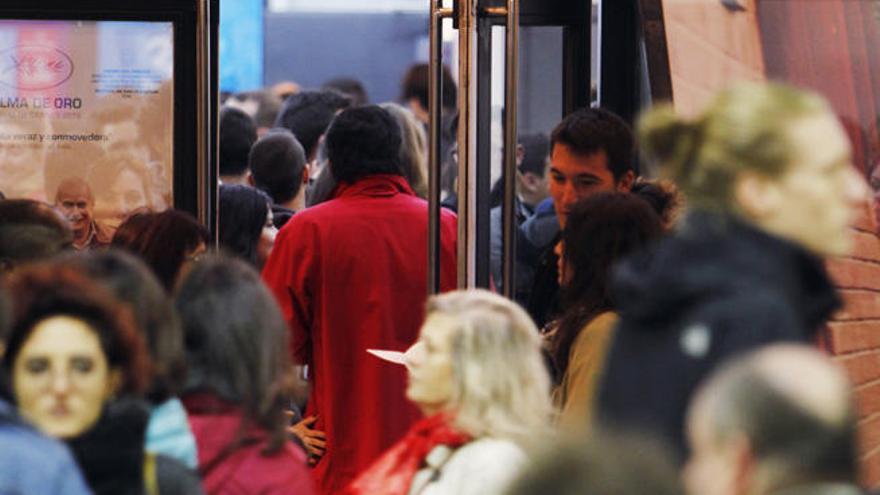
[599,83,867,460]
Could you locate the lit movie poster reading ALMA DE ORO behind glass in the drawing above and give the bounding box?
[0,20,174,229]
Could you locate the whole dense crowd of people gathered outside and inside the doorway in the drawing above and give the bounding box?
[0,67,867,495]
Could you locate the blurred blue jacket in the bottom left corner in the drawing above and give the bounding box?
[0,400,92,495]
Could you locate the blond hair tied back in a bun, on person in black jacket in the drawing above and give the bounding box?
[638,83,830,212]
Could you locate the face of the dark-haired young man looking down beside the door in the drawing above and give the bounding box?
[550,143,635,229]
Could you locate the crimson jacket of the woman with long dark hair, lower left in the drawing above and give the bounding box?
[183,394,315,495]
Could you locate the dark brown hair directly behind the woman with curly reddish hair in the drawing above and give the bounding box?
[59,249,186,404]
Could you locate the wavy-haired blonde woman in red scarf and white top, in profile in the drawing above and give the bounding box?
[346,290,551,495]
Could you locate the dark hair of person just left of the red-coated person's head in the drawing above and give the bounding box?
[275,89,351,159]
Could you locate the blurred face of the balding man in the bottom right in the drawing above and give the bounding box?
[684,404,736,495]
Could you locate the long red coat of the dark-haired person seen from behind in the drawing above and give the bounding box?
[263,175,456,494]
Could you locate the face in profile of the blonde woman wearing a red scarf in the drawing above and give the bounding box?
[406,313,455,414]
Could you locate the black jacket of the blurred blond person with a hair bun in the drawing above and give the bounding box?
[599,213,840,462]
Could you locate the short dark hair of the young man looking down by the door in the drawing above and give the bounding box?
[550,108,638,180]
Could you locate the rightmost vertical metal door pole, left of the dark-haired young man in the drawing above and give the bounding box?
[502,0,519,298]
